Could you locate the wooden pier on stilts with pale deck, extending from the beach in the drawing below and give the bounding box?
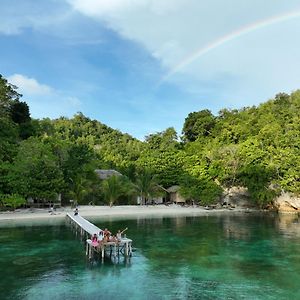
[67,213,132,259]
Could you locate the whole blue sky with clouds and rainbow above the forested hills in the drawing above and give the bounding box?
[0,0,300,140]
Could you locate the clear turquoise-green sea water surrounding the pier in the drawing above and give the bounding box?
[0,214,300,300]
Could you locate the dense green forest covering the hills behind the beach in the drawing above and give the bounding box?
[0,75,300,208]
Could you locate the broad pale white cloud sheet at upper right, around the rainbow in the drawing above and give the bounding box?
[67,0,300,107]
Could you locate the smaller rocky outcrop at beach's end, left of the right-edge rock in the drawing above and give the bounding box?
[222,186,253,207]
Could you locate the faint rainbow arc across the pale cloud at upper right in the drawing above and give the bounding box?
[158,10,300,86]
